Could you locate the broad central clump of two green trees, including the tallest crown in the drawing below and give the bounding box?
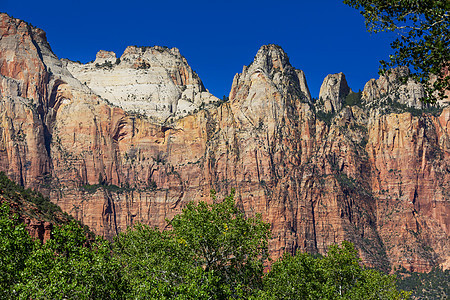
[114,191,269,299]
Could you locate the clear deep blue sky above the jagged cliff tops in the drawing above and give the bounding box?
[0,0,392,98]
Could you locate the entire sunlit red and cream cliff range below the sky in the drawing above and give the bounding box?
[0,14,450,271]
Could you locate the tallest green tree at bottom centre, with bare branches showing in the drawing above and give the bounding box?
[169,190,270,298]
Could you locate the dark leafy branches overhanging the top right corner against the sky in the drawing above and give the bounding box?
[344,0,450,102]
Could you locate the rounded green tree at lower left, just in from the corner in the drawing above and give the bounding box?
[14,222,125,299]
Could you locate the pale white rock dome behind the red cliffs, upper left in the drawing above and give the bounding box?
[64,46,220,124]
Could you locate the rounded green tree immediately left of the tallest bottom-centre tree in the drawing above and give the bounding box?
[114,224,217,299]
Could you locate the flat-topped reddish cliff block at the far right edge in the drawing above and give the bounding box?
[366,107,450,271]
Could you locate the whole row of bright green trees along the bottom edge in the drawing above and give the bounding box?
[0,191,414,299]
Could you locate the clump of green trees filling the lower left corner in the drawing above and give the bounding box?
[0,204,123,299]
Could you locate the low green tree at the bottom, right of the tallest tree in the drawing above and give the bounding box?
[258,241,408,300]
